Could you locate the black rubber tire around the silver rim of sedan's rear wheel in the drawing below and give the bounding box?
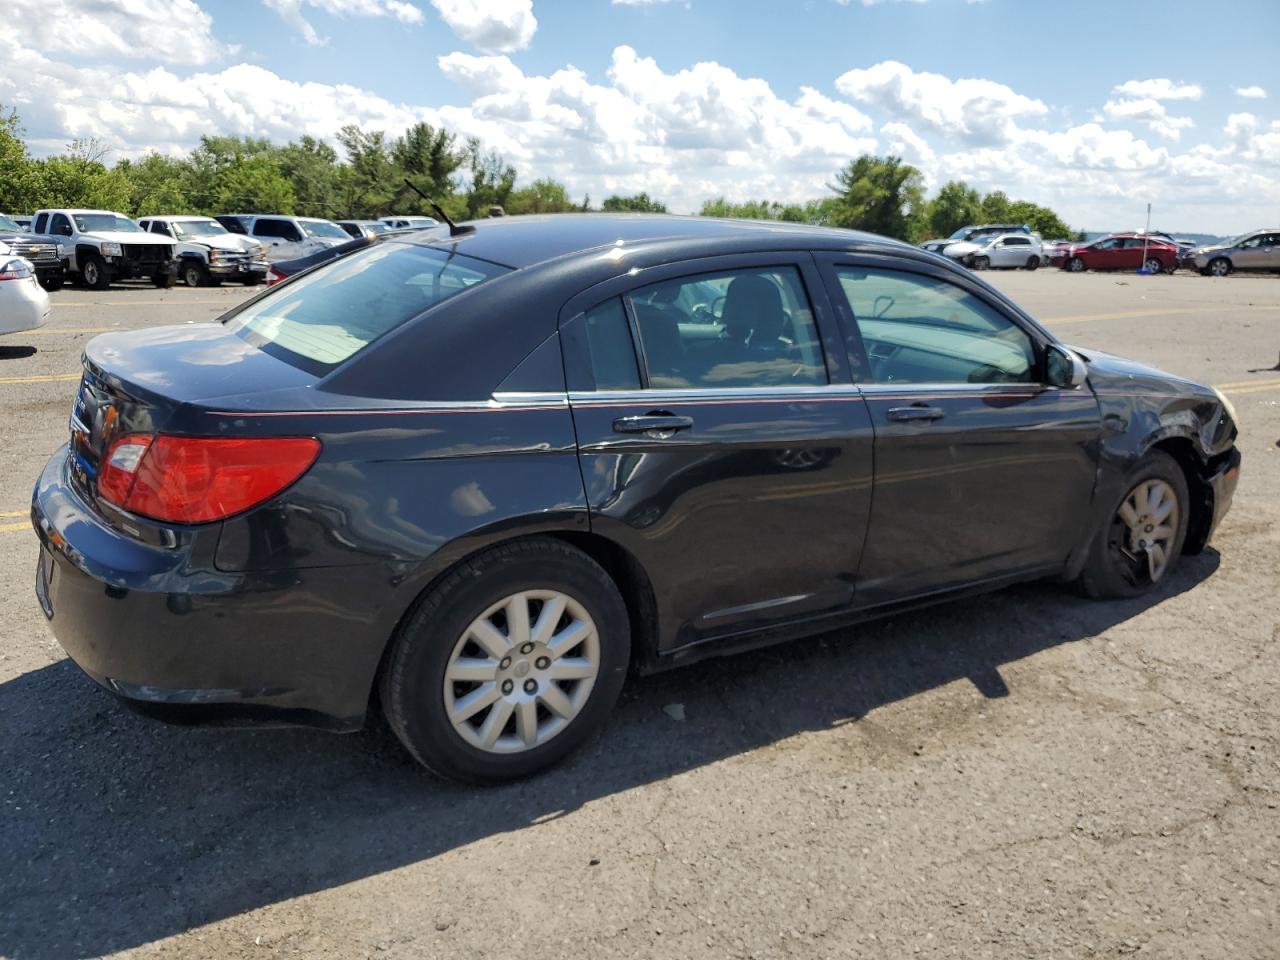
[380,538,631,783]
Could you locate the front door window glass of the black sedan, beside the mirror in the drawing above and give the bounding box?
[836,266,1036,384]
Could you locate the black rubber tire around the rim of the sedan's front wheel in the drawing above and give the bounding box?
[1079,451,1190,599]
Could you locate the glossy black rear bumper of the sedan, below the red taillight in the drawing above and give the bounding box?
[31,448,388,730]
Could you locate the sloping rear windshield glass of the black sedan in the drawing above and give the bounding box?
[227,241,507,372]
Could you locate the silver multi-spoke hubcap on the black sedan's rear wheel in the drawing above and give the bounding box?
[444,590,600,754]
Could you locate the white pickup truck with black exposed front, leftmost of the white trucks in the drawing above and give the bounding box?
[32,210,178,291]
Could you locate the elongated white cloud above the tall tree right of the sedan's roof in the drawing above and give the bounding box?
[836,60,1048,146]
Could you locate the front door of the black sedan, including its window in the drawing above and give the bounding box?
[823,256,1100,607]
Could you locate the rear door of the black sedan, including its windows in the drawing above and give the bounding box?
[562,253,873,649]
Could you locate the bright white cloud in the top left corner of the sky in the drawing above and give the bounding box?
[4,0,232,64]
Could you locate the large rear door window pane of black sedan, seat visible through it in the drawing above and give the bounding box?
[630,266,827,389]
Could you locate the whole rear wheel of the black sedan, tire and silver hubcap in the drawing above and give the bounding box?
[381,539,631,783]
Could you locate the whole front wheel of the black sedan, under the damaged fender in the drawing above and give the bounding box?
[1080,451,1190,598]
